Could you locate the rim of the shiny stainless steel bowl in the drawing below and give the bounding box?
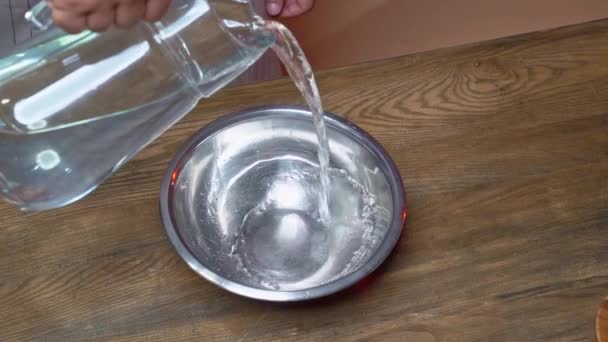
[160,105,407,302]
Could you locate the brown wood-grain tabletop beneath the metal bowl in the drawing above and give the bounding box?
[0,21,608,341]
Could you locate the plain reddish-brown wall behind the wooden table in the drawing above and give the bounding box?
[285,0,608,69]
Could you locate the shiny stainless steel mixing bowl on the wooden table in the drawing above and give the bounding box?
[161,107,405,301]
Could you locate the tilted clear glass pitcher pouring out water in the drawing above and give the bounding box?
[0,0,274,210]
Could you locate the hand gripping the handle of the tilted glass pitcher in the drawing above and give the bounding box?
[48,0,171,33]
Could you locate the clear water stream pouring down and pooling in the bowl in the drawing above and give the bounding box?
[222,21,390,291]
